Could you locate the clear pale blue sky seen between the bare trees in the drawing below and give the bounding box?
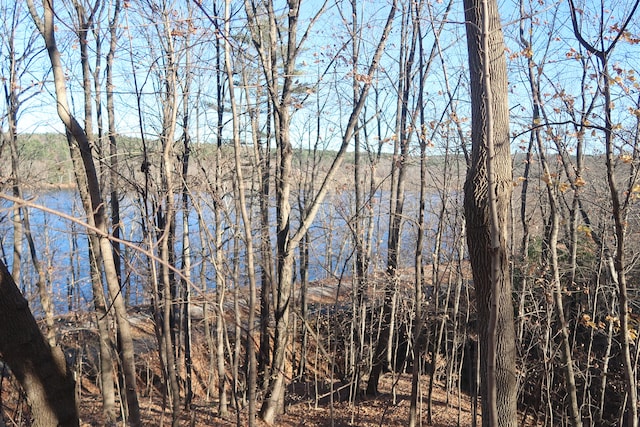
[0,0,640,158]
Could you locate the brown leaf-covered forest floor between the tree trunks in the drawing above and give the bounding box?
[0,276,535,427]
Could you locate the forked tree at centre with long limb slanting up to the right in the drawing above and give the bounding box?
[245,0,397,423]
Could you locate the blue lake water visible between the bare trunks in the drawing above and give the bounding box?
[0,190,460,313]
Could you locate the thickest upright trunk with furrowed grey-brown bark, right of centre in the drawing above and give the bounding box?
[464,0,517,426]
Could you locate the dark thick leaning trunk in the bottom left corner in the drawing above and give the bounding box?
[0,262,79,427]
